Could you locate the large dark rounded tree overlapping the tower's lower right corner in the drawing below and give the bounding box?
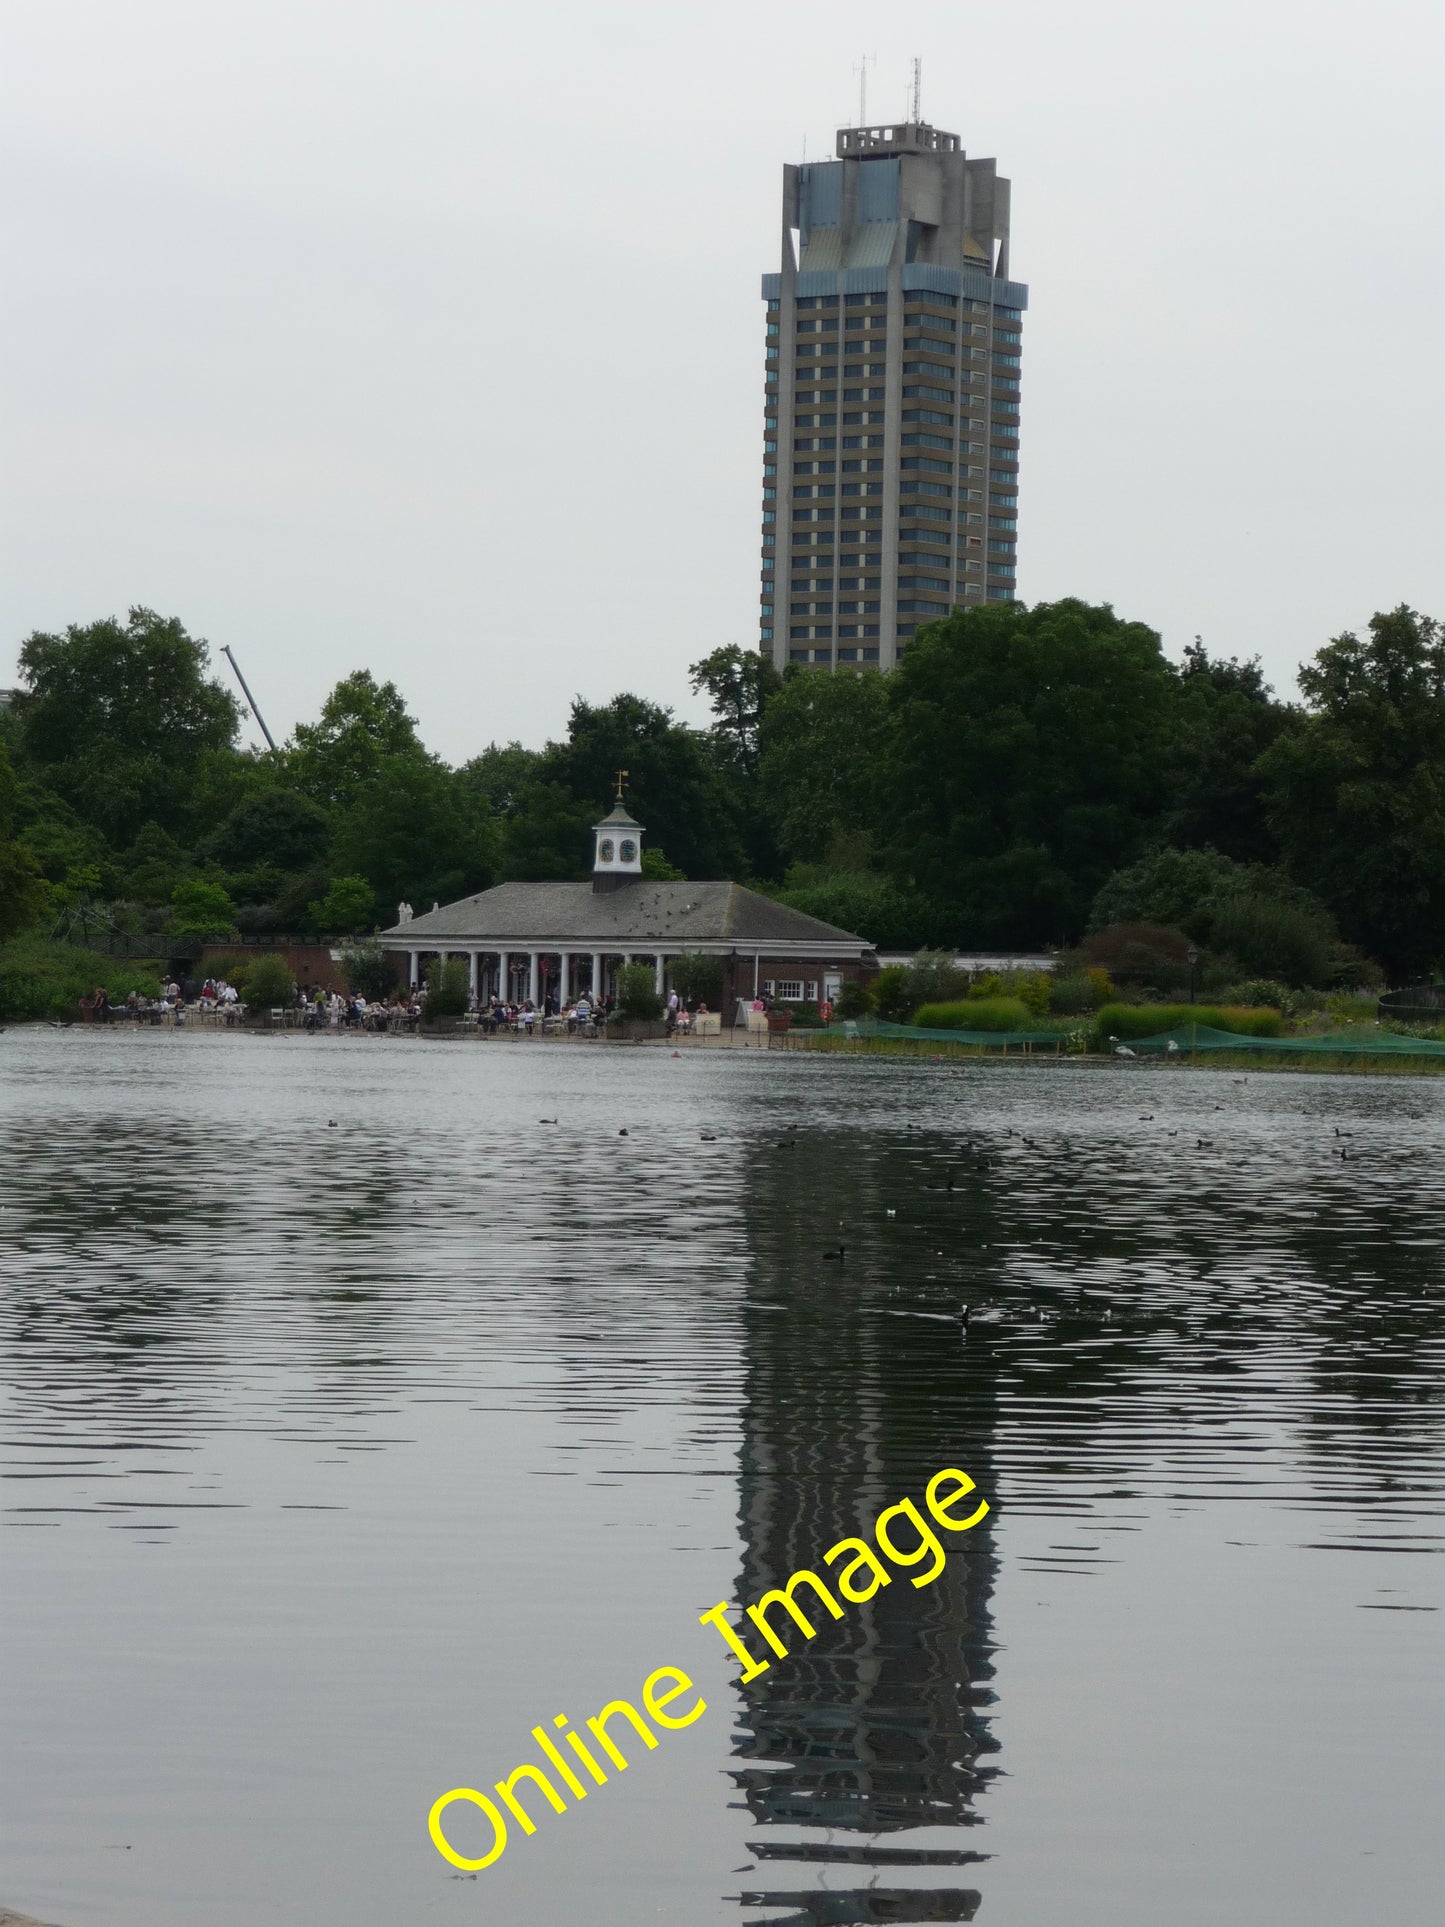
[882,601,1177,944]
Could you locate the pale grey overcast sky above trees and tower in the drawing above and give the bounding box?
[0,0,1445,761]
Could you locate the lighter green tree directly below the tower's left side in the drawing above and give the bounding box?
[759,671,888,863]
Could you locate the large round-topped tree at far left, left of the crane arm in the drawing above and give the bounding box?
[15,609,237,846]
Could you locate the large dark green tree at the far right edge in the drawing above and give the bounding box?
[1260,605,1445,981]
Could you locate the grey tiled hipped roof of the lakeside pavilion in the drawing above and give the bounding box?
[383,877,871,956]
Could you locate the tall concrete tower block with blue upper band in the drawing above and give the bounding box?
[759,121,1029,669]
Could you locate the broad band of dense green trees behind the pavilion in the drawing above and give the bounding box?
[0,601,1445,986]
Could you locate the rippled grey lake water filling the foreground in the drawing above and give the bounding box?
[0,1027,1445,1927]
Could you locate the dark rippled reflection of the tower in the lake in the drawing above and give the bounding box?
[736,1137,994,1927]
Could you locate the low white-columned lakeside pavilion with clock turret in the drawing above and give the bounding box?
[380,794,877,1012]
